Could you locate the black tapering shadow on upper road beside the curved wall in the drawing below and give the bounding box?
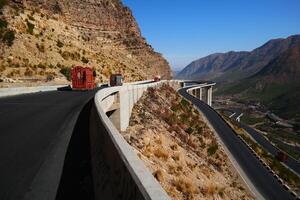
[56,99,94,200]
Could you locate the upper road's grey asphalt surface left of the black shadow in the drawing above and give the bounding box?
[0,91,95,200]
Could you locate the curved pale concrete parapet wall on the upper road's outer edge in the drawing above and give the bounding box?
[90,81,182,200]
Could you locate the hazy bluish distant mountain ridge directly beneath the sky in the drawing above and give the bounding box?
[177,35,300,81]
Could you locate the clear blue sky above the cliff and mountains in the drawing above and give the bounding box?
[123,0,300,70]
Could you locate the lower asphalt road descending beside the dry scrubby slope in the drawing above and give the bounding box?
[179,88,294,200]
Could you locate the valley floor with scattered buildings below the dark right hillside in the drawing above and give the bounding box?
[213,96,300,161]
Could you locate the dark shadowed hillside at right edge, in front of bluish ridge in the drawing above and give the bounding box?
[218,45,300,119]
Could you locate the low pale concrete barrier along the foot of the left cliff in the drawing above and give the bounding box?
[0,85,67,97]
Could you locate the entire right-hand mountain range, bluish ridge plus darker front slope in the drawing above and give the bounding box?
[177,35,300,121]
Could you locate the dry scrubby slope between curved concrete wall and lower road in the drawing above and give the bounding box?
[122,85,253,199]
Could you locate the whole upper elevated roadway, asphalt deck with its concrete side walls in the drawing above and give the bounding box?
[0,80,216,200]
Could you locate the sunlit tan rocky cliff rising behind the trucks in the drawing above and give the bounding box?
[0,0,172,86]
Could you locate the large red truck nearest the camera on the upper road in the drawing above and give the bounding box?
[71,66,95,90]
